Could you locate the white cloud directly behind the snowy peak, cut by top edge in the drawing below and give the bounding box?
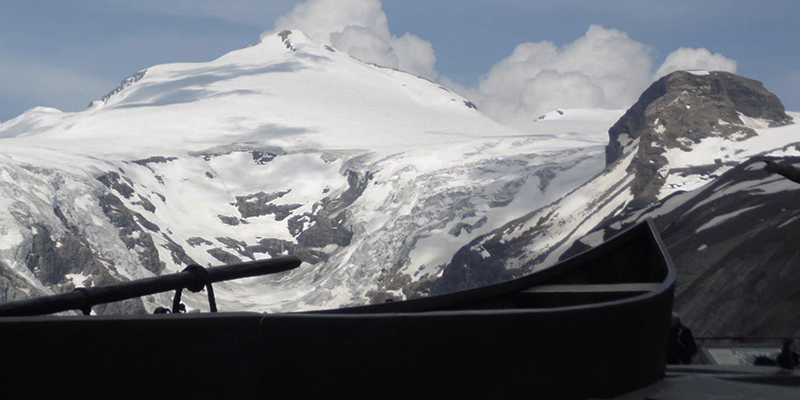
[272,0,438,79]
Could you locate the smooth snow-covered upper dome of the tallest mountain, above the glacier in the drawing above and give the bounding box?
[0,30,500,154]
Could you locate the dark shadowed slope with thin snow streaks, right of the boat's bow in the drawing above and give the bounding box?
[656,163,800,337]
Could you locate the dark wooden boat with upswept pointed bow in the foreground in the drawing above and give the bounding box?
[0,221,675,399]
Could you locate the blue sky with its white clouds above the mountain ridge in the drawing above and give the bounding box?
[0,0,800,121]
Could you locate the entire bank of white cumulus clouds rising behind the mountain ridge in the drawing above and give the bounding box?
[264,0,736,124]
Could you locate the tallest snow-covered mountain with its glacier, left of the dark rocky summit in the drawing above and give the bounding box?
[0,31,621,313]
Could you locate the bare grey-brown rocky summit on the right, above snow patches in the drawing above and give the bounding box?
[606,71,792,206]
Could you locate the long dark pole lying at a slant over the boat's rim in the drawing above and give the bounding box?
[0,257,301,317]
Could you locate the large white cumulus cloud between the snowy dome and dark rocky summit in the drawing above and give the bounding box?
[454,25,653,122]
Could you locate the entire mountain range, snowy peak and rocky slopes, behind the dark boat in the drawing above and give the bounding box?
[0,30,800,334]
